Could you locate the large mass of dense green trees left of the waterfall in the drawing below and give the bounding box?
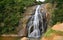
[0,0,35,34]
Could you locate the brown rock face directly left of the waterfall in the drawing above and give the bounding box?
[18,6,35,36]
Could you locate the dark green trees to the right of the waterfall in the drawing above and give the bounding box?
[46,0,63,26]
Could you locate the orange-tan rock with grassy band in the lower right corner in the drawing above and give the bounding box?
[41,23,63,40]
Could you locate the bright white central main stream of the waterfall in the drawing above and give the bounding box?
[28,5,40,37]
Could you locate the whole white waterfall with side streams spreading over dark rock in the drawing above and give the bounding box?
[27,5,44,38]
